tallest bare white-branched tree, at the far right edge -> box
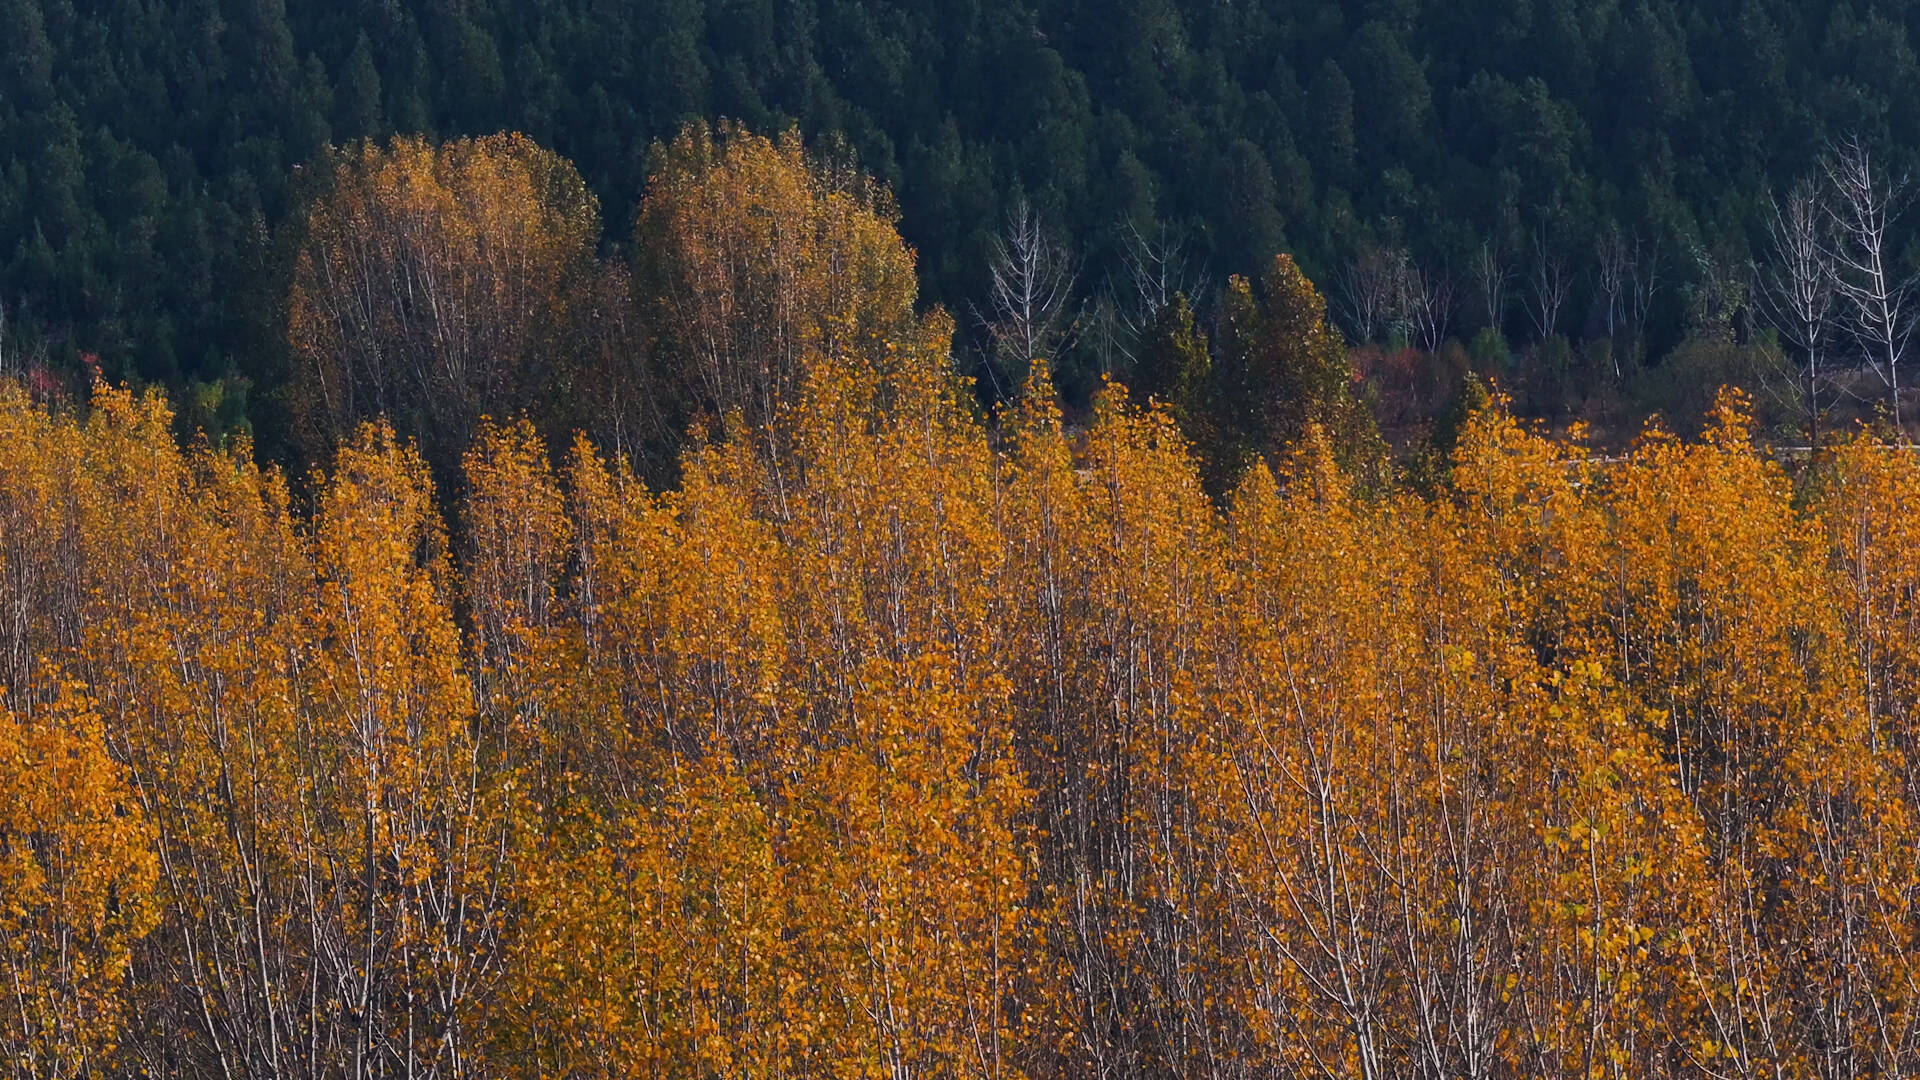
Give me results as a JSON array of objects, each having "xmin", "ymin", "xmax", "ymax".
[{"xmin": 1826, "ymin": 136, "xmax": 1914, "ymax": 436}]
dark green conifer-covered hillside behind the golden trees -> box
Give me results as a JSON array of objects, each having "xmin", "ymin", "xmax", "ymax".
[{"xmin": 11, "ymin": 0, "xmax": 1920, "ymax": 441}]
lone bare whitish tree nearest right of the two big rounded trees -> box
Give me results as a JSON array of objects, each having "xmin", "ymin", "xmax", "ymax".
[{"xmin": 973, "ymin": 200, "xmax": 1079, "ymax": 394}]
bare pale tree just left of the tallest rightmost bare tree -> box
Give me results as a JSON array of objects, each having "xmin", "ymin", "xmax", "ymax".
[{"xmin": 1755, "ymin": 179, "xmax": 1837, "ymax": 452}]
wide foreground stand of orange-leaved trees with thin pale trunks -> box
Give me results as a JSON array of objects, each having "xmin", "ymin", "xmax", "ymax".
[{"xmin": 11, "ymin": 127, "xmax": 1920, "ymax": 1080}]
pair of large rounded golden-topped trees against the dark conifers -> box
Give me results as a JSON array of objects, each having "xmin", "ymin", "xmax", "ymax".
[{"xmin": 288, "ymin": 125, "xmax": 918, "ymax": 475}]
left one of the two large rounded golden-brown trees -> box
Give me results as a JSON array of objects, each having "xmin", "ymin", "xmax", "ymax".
[{"xmin": 288, "ymin": 135, "xmax": 599, "ymax": 461}]
